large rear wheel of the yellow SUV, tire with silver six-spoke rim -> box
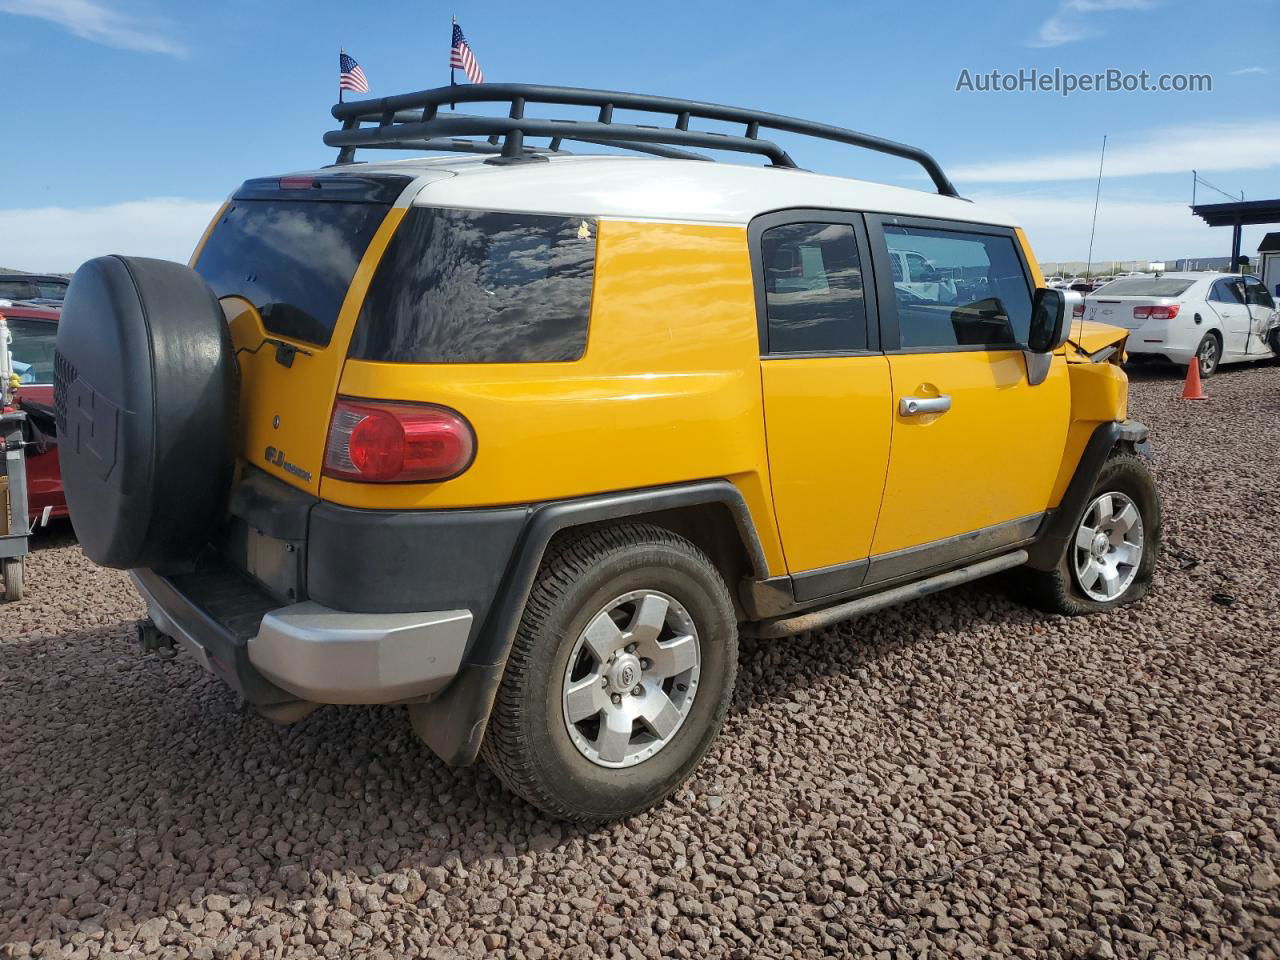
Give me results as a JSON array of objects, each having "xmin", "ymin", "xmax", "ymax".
[{"xmin": 481, "ymin": 524, "xmax": 737, "ymax": 823}]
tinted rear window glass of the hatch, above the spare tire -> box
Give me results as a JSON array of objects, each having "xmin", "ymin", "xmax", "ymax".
[{"xmin": 196, "ymin": 200, "xmax": 389, "ymax": 347}]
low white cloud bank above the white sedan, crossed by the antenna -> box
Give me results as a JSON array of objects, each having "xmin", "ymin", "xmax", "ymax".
[{"xmin": 972, "ymin": 189, "xmax": 1266, "ymax": 262}]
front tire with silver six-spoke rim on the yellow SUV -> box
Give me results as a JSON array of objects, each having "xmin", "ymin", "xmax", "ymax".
[{"xmin": 1019, "ymin": 453, "xmax": 1162, "ymax": 617}]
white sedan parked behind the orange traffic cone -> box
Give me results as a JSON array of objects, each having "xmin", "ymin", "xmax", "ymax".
[{"xmin": 1084, "ymin": 273, "xmax": 1280, "ymax": 376}]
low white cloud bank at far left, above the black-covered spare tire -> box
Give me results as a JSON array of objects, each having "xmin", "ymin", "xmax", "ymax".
[{"xmin": 0, "ymin": 197, "xmax": 219, "ymax": 273}]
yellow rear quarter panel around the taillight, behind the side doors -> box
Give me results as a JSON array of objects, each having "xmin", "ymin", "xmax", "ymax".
[{"xmin": 320, "ymin": 220, "xmax": 783, "ymax": 572}]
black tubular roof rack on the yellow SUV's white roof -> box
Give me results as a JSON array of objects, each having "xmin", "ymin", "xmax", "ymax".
[{"xmin": 324, "ymin": 83, "xmax": 957, "ymax": 197}]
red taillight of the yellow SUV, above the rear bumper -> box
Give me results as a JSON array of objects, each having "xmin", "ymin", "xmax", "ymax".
[{"xmin": 324, "ymin": 397, "xmax": 476, "ymax": 484}]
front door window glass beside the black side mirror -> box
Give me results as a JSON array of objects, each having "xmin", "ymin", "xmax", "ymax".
[{"xmin": 884, "ymin": 225, "xmax": 1032, "ymax": 349}]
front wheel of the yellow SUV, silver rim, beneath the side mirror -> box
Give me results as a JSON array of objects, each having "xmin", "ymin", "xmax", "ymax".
[{"xmin": 1021, "ymin": 453, "xmax": 1161, "ymax": 616}]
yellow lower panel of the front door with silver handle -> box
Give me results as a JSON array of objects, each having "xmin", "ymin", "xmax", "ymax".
[{"xmin": 872, "ymin": 351, "xmax": 1071, "ymax": 554}]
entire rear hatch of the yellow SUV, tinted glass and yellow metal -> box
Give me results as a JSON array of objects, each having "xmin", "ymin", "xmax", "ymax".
[{"xmin": 193, "ymin": 174, "xmax": 412, "ymax": 495}]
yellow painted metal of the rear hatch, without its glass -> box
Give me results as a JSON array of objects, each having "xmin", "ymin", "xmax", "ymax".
[{"xmin": 215, "ymin": 209, "xmax": 404, "ymax": 494}]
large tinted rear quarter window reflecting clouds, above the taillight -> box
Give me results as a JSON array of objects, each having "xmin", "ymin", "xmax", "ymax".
[{"xmin": 351, "ymin": 207, "xmax": 595, "ymax": 364}]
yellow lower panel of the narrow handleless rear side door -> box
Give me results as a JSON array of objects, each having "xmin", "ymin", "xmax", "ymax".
[{"xmin": 762, "ymin": 356, "xmax": 892, "ymax": 571}]
